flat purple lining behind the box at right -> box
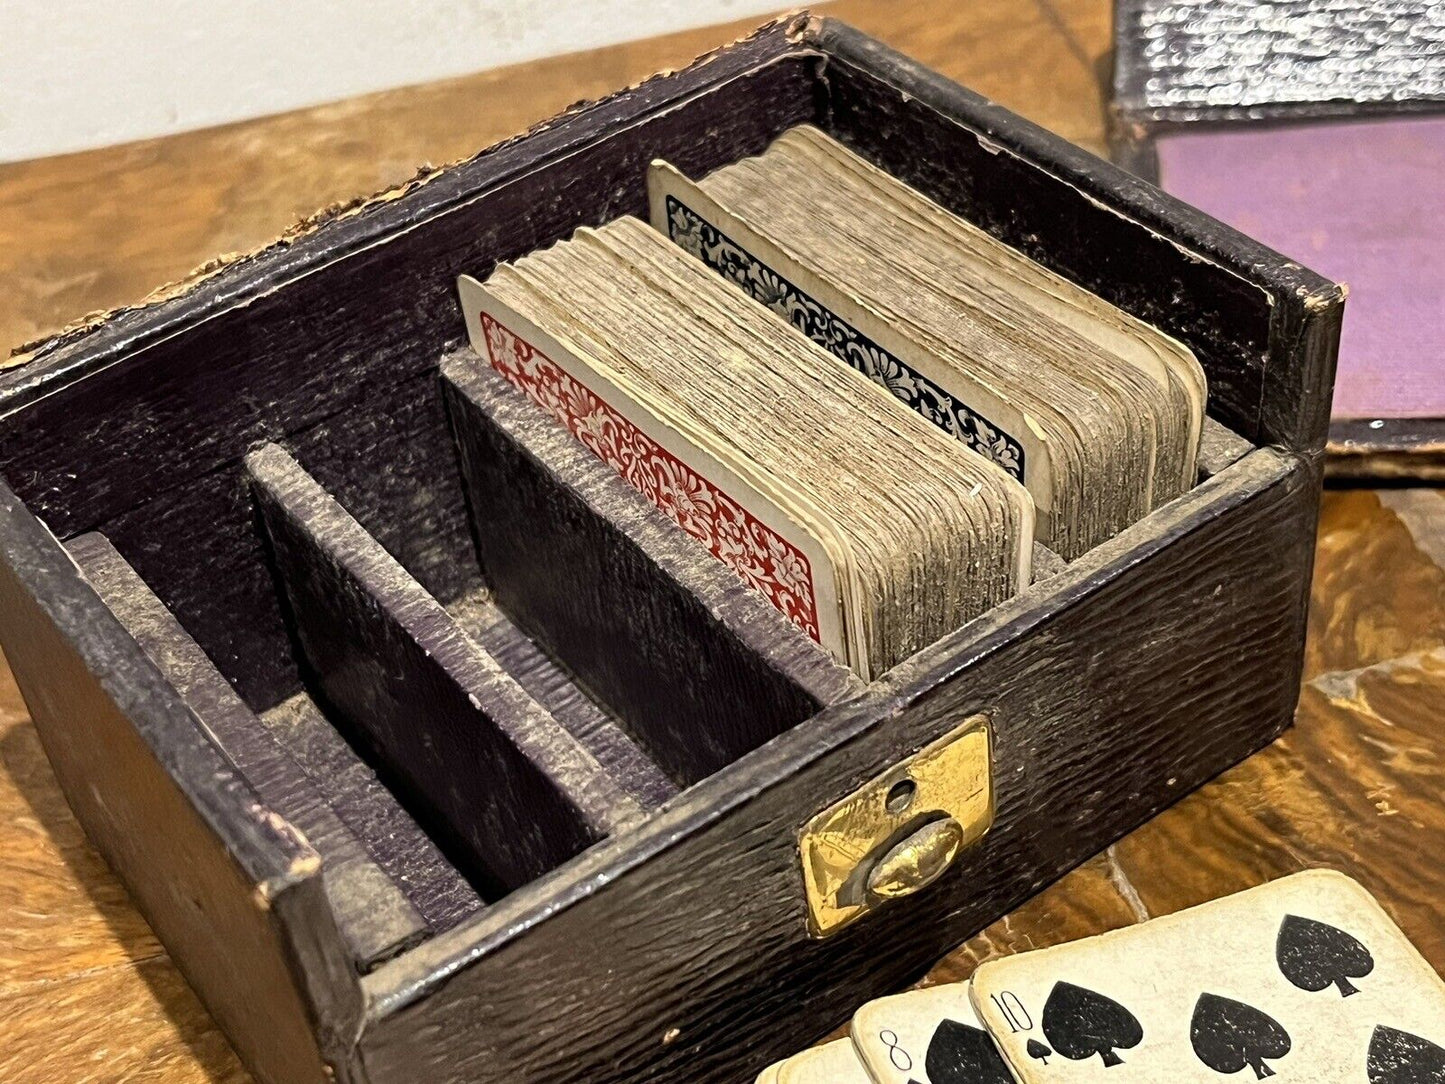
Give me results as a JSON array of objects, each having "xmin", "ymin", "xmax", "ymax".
[{"xmin": 1157, "ymin": 116, "xmax": 1445, "ymax": 418}]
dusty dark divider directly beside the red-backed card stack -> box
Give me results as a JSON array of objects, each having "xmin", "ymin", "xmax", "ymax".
[{"xmin": 441, "ymin": 358, "xmax": 863, "ymax": 785}]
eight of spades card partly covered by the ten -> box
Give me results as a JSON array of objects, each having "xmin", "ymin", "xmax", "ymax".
[{"xmin": 851, "ymin": 983, "xmax": 1013, "ymax": 1084}]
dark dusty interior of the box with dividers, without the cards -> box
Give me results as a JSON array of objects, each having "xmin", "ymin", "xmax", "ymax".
[{"xmin": 0, "ymin": 19, "xmax": 1312, "ymax": 1011}]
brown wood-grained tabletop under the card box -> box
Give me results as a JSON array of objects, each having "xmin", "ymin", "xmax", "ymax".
[{"xmin": 0, "ymin": 0, "xmax": 1445, "ymax": 1084}]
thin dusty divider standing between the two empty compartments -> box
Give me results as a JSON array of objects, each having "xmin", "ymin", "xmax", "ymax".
[{"xmin": 246, "ymin": 445, "xmax": 643, "ymax": 896}]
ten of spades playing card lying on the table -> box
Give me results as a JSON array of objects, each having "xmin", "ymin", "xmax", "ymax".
[{"xmin": 971, "ymin": 870, "xmax": 1445, "ymax": 1084}]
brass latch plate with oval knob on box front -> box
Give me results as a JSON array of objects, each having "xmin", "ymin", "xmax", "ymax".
[{"xmin": 798, "ymin": 714, "xmax": 993, "ymax": 938}]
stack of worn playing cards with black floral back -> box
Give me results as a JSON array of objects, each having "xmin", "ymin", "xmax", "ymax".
[{"xmin": 649, "ymin": 127, "xmax": 1205, "ymax": 558}]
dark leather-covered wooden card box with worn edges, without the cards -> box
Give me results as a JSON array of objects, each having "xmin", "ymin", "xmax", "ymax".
[{"xmin": 0, "ymin": 16, "xmax": 1342, "ymax": 1084}]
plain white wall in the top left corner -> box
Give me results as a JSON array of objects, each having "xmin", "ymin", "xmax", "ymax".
[{"xmin": 0, "ymin": 0, "xmax": 780, "ymax": 162}]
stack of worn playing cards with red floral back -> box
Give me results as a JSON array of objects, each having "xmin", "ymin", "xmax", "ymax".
[{"xmin": 461, "ymin": 218, "xmax": 1033, "ymax": 679}]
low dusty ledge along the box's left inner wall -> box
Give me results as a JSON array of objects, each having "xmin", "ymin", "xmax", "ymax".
[{"xmin": 66, "ymin": 533, "xmax": 450, "ymax": 971}]
